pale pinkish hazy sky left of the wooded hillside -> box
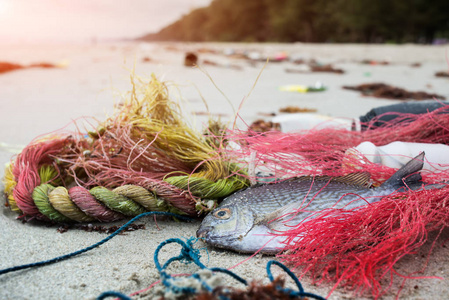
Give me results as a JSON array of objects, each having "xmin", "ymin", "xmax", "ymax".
[{"xmin": 0, "ymin": 0, "xmax": 211, "ymax": 43}]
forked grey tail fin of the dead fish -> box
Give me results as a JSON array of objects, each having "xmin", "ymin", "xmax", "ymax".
[{"xmin": 381, "ymin": 152, "xmax": 425, "ymax": 188}]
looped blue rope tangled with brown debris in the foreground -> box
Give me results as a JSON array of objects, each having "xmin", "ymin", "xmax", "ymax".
[{"xmin": 149, "ymin": 238, "xmax": 324, "ymax": 300}]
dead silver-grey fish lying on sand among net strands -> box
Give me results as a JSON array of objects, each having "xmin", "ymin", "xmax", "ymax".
[{"xmin": 196, "ymin": 152, "xmax": 434, "ymax": 254}]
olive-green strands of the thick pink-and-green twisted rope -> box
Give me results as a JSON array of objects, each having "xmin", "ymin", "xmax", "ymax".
[{"xmin": 32, "ymin": 172, "xmax": 247, "ymax": 222}]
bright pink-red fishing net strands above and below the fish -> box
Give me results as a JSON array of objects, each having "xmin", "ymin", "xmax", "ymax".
[{"xmin": 227, "ymin": 106, "xmax": 449, "ymax": 298}]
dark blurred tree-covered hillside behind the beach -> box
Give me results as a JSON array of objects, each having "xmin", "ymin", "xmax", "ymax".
[{"xmin": 142, "ymin": 0, "xmax": 449, "ymax": 43}]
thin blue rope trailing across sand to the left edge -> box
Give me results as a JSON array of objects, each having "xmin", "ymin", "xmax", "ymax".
[{"xmin": 0, "ymin": 211, "xmax": 192, "ymax": 275}]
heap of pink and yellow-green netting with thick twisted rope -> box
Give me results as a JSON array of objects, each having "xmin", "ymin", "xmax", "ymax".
[{"xmin": 4, "ymin": 76, "xmax": 248, "ymax": 222}]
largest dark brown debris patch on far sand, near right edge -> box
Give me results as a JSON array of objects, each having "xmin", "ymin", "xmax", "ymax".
[{"xmin": 343, "ymin": 83, "xmax": 446, "ymax": 100}]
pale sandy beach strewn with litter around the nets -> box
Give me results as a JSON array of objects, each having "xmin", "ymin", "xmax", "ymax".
[{"xmin": 0, "ymin": 42, "xmax": 449, "ymax": 299}]
